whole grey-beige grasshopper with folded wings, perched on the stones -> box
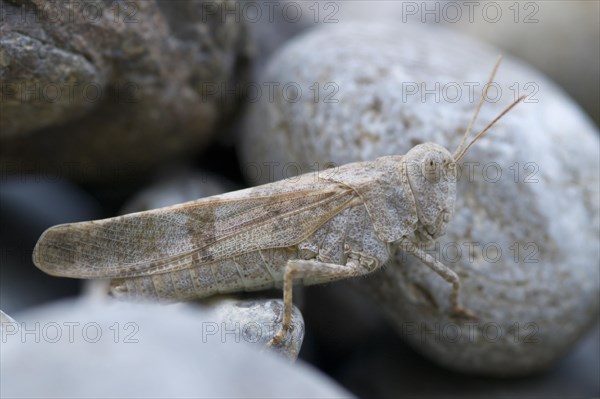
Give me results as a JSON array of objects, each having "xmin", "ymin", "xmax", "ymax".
[{"xmin": 33, "ymin": 59, "xmax": 523, "ymax": 344}]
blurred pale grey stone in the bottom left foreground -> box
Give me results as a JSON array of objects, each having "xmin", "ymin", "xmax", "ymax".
[{"xmin": 0, "ymin": 301, "xmax": 344, "ymax": 398}]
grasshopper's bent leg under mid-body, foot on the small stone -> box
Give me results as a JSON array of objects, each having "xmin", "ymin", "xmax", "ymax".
[{"xmin": 267, "ymin": 259, "xmax": 366, "ymax": 346}]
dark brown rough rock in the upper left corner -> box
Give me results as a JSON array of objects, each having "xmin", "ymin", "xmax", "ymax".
[{"xmin": 0, "ymin": 0, "xmax": 252, "ymax": 181}]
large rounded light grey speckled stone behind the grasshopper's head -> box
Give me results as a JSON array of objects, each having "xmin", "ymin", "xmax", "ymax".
[{"xmin": 240, "ymin": 23, "xmax": 600, "ymax": 376}]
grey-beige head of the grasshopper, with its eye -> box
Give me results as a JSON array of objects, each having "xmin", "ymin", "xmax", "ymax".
[{"xmin": 405, "ymin": 143, "xmax": 456, "ymax": 242}]
